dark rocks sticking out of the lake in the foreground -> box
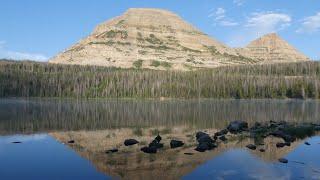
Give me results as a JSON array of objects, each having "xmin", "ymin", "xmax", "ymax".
[{"xmin": 106, "ymin": 121, "xmax": 320, "ymax": 158}]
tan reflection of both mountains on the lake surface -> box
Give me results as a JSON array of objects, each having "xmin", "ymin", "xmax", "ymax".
[{"xmin": 50, "ymin": 126, "xmax": 312, "ymax": 179}]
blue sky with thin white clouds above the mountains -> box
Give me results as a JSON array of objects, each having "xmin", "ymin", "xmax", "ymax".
[{"xmin": 0, "ymin": 0, "xmax": 320, "ymax": 61}]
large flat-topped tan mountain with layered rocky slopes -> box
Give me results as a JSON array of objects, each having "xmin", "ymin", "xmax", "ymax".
[{"xmin": 50, "ymin": 9, "xmax": 255, "ymax": 70}]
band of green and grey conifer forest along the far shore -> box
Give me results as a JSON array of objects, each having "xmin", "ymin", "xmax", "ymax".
[{"xmin": 0, "ymin": 61, "xmax": 320, "ymax": 98}]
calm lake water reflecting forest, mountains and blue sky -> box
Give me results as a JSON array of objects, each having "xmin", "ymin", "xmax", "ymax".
[{"xmin": 0, "ymin": 99, "xmax": 320, "ymax": 180}]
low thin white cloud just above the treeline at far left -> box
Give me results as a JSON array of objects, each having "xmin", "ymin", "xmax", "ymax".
[{"xmin": 0, "ymin": 41, "xmax": 48, "ymax": 62}]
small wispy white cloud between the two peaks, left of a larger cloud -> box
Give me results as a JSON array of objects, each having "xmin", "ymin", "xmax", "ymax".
[{"xmin": 208, "ymin": 7, "xmax": 239, "ymax": 26}]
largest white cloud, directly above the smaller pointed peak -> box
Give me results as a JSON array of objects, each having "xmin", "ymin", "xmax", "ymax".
[{"xmin": 227, "ymin": 12, "xmax": 292, "ymax": 47}]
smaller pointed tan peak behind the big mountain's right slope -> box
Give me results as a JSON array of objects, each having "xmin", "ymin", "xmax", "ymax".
[{"xmin": 238, "ymin": 33, "xmax": 310, "ymax": 63}]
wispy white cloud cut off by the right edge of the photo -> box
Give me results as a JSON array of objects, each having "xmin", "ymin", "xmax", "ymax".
[{"xmin": 297, "ymin": 12, "xmax": 320, "ymax": 33}]
